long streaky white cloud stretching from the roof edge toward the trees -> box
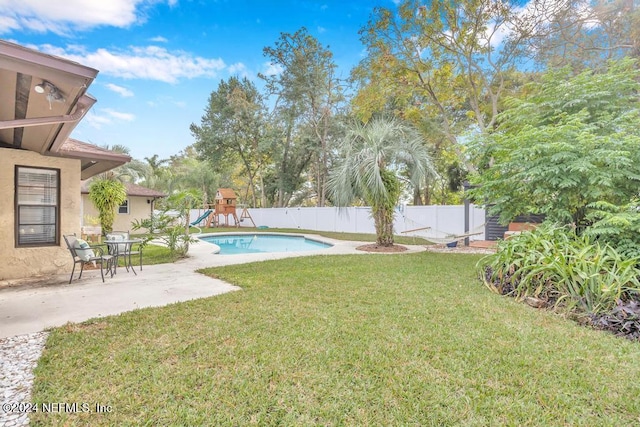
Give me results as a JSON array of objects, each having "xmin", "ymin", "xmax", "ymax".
[{"xmin": 37, "ymin": 44, "xmax": 226, "ymax": 83}]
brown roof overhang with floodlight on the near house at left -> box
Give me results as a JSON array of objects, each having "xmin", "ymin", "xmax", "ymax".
[{"xmin": 0, "ymin": 40, "xmax": 131, "ymax": 179}]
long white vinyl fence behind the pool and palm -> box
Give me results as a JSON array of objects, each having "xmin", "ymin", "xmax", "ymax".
[{"xmin": 191, "ymin": 205, "xmax": 485, "ymax": 240}]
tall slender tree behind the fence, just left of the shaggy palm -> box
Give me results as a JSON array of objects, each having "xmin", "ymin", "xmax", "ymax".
[{"xmin": 259, "ymin": 27, "xmax": 344, "ymax": 206}]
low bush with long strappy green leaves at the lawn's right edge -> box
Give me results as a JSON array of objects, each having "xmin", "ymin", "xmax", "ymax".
[{"xmin": 479, "ymin": 224, "xmax": 640, "ymax": 314}]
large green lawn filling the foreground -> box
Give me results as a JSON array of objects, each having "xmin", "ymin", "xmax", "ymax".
[{"xmin": 31, "ymin": 253, "xmax": 640, "ymax": 426}]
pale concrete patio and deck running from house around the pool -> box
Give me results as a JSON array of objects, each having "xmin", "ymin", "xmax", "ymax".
[{"xmin": 0, "ymin": 233, "xmax": 425, "ymax": 338}]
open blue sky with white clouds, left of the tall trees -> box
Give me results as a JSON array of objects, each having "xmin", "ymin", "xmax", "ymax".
[{"xmin": 0, "ymin": 0, "xmax": 394, "ymax": 160}]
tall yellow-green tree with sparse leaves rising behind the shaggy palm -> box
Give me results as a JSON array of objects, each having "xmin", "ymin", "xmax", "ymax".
[{"xmin": 354, "ymin": 0, "xmax": 526, "ymax": 172}]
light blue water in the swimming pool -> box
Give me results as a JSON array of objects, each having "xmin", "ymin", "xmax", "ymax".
[{"xmin": 200, "ymin": 234, "xmax": 332, "ymax": 255}]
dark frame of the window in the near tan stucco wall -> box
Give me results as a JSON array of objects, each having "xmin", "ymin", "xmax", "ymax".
[{"xmin": 13, "ymin": 165, "xmax": 62, "ymax": 248}]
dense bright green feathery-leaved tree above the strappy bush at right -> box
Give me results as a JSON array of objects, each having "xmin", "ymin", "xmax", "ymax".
[{"xmin": 475, "ymin": 59, "xmax": 640, "ymax": 227}]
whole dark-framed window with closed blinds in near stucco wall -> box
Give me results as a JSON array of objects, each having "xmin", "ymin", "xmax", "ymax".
[{"xmin": 15, "ymin": 166, "xmax": 60, "ymax": 246}]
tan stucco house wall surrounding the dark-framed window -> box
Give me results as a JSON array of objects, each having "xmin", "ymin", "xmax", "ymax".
[{"xmin": 0, "ymin": 148, "xmax": 80, "ymax": 280}]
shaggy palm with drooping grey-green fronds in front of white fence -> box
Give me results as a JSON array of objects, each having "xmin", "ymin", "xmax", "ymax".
[{"xmin": 329, "ymin": 118, "xmax": 436, "ymax": 246}]
